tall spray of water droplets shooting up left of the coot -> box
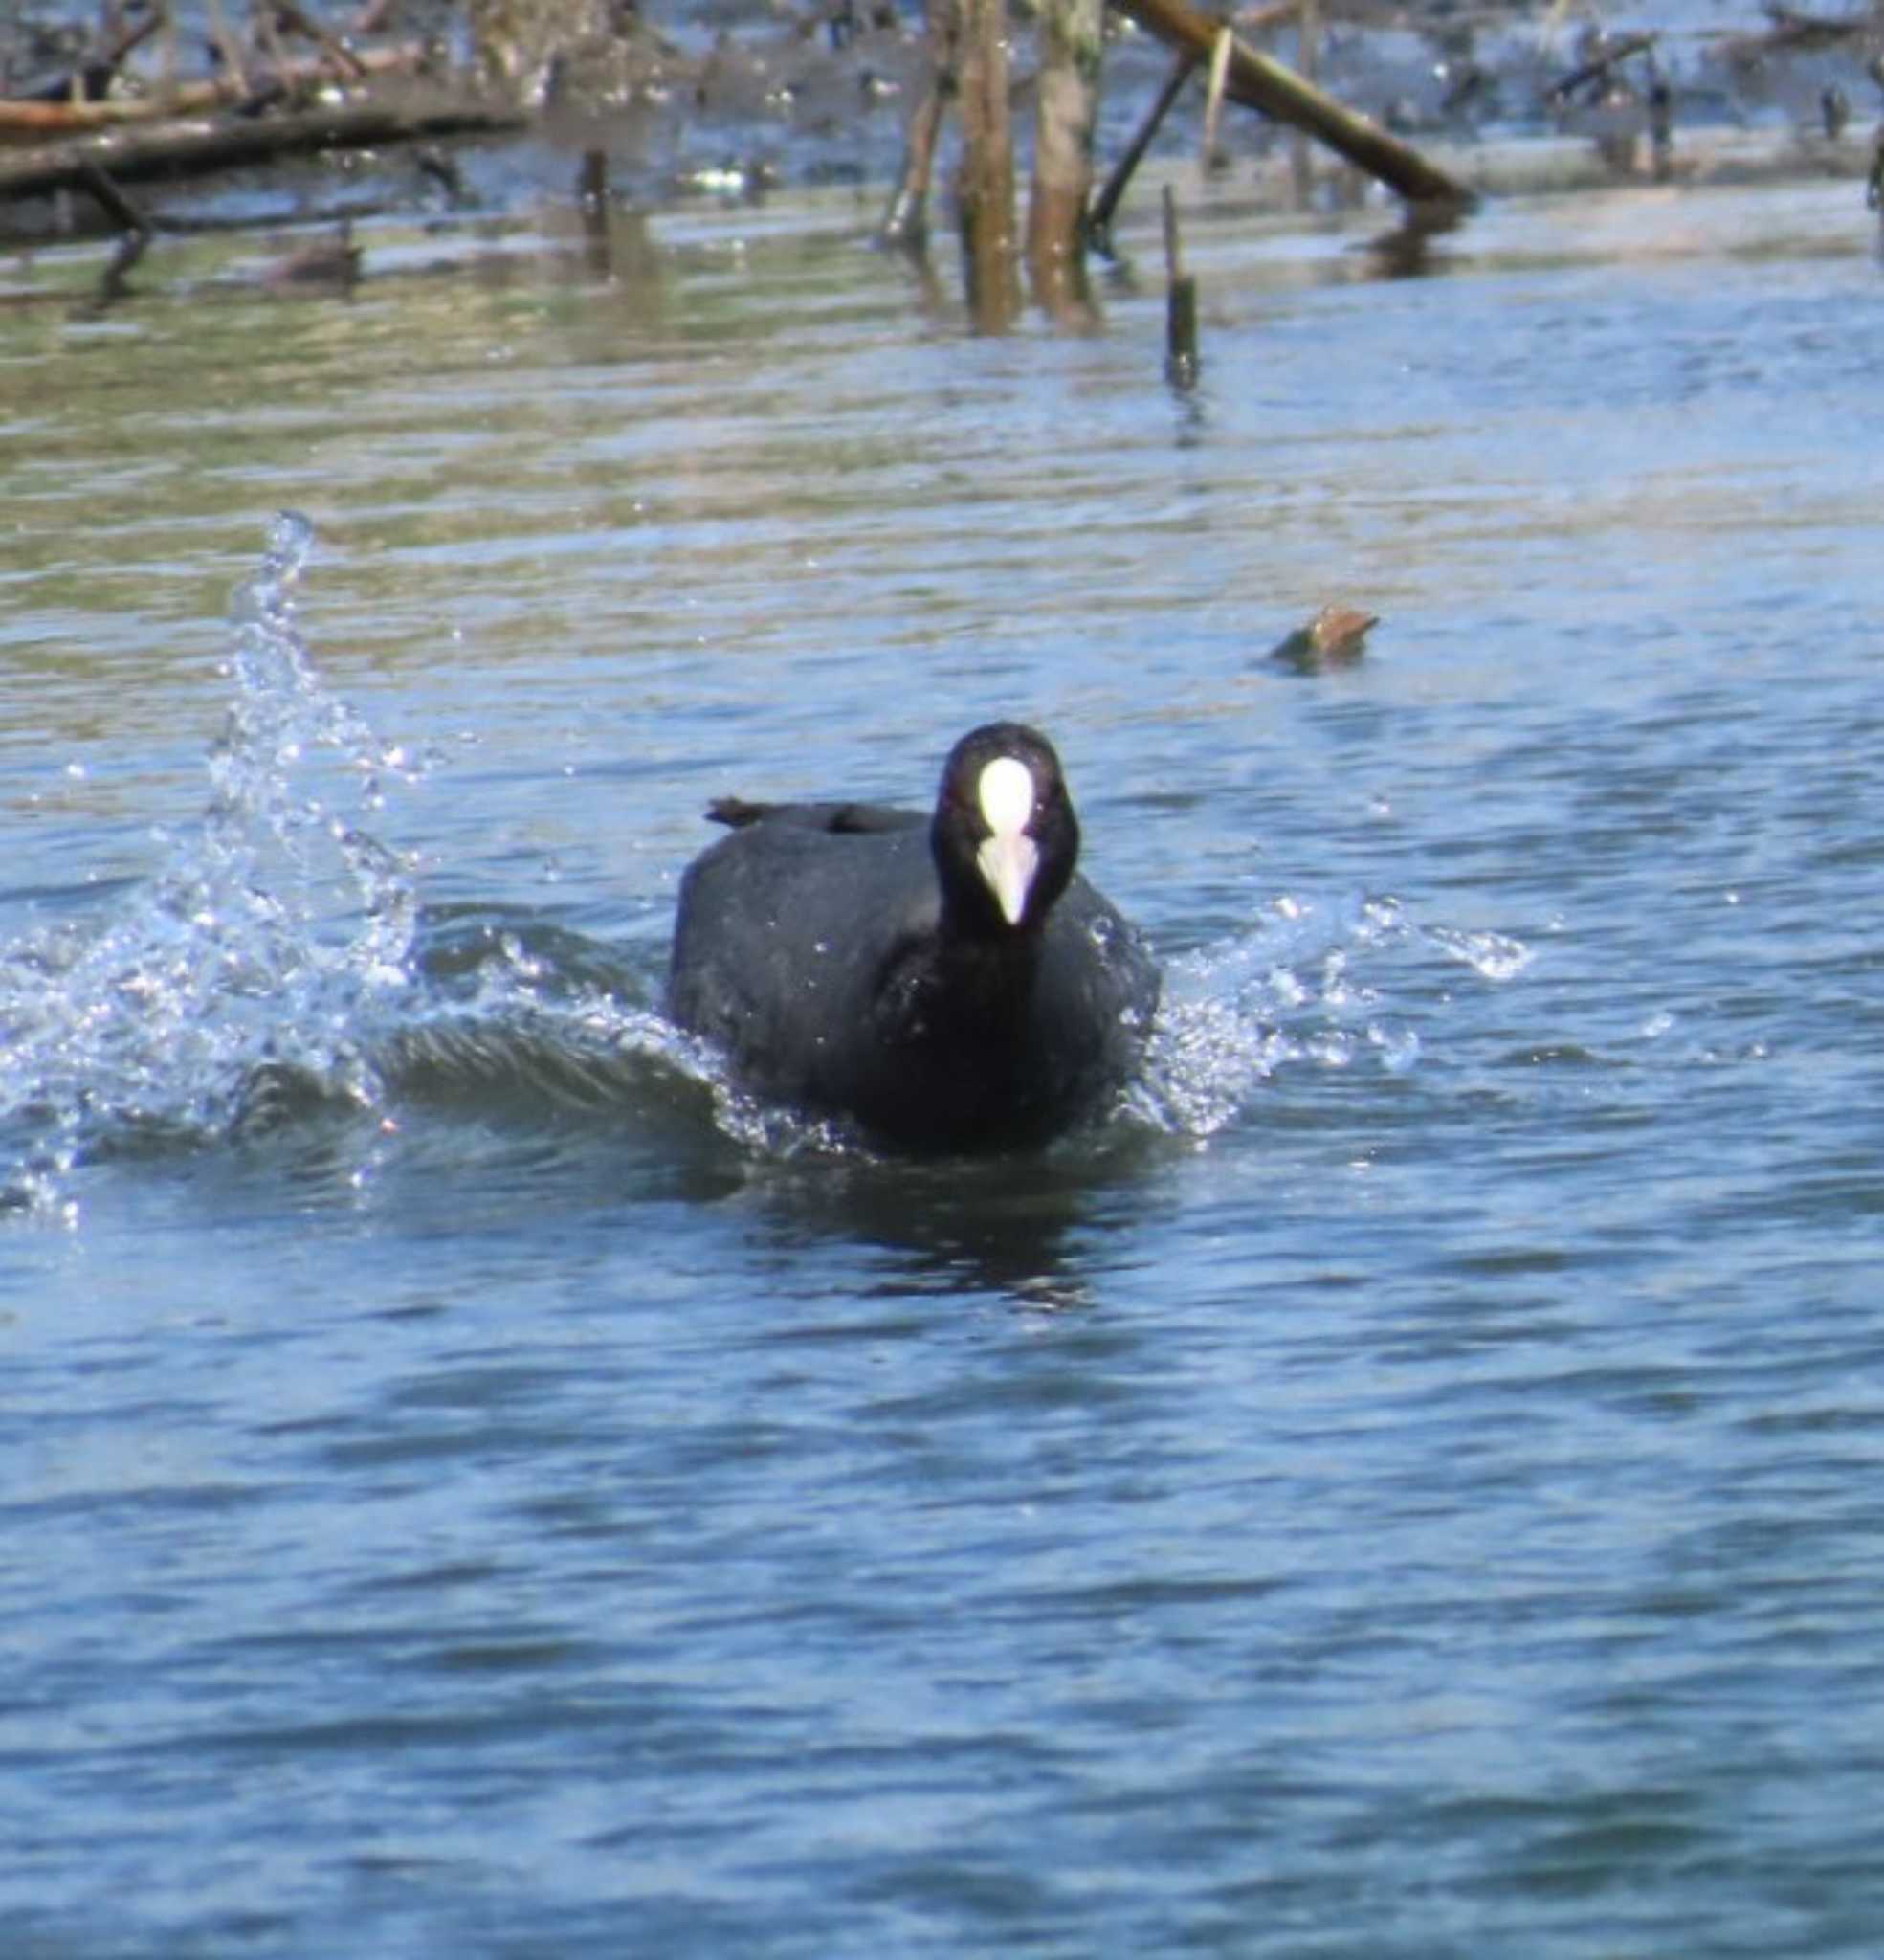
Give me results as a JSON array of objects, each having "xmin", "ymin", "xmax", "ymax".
[{"xmin": 0, "ymin": 514, "xmax": 433, "ymax": 1217}]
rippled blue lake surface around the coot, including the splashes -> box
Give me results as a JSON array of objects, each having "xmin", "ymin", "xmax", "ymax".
[{"xmin": 0, "ymin": 160, "xmax": 1884, "ymax": 1960}]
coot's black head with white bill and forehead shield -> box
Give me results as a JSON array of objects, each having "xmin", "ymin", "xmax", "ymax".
[{"xmin": 929, "ymin": 722, "xmax": 1080, "ymax": 935}]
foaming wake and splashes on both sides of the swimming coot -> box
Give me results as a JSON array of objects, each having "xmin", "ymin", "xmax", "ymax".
[{"xmin": 0, "ymin": 514, "xmax": 1531, "ymax": 1219}]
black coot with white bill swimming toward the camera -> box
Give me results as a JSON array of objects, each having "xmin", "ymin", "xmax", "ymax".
[{"xmin": 667, "ymin": 722, "xmax": 1159, "ymax": 1150}]
